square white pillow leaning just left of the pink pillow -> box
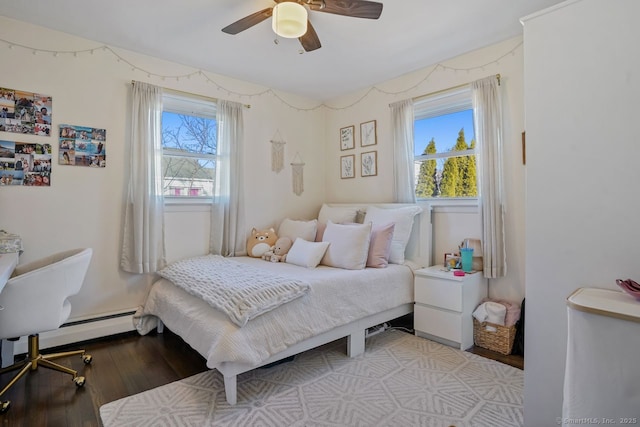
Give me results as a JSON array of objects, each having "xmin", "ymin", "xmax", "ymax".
[{"xmin": 321, "ymin": 221, "xmax": 371, "ymax": 270}]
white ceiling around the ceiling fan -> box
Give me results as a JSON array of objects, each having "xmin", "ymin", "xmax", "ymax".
[{"xmin": 0, "ymin": 0, "xmax": 561, "ymax": 100}]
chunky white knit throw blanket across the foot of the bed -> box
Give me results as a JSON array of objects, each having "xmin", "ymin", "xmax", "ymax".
[{"xmin": 158, "ymin": 255, "xmax": 310, "ymax": 327}]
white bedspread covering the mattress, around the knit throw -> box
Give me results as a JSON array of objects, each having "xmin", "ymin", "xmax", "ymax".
[{"xmin": 135, "ymin": 257, "xmax": 413, "ymax": 369}]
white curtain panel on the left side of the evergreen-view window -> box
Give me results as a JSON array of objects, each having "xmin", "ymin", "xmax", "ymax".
[{"xmin": 389, "ymin": 99, "xmax": 416, "ymax": 203}]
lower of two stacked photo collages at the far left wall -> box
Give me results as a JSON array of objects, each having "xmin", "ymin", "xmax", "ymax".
[{"xmin": 0, "ymin": 141, "xmax": 51, "ymax": 186}]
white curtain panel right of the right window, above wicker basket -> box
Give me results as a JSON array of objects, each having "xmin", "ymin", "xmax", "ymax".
[{"xmin": 471, "ymin": 76, "xmax": 507, "ymax": 278}]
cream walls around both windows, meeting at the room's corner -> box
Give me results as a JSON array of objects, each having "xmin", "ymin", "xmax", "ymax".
[{"xmin": 0, "ymin": 17, "xmax": 524, "ymax": 338}]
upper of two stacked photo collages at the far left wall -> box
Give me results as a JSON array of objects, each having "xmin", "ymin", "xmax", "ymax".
[{"xmin": 0, "ymin": 87, "xmax": 53, "ymax": 136}]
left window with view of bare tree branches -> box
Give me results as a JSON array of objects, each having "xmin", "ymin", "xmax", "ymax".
[{"xmin": 162, "ymin": 92, "xmax": 218, "ymax": 200}]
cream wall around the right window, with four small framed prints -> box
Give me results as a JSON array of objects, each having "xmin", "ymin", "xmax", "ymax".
[{"xmin": 326, "ymin": 37, "xmax": 524, "ymax": 303}]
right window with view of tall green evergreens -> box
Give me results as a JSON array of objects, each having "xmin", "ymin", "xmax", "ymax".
[{"xmin": 414, "ymin": 86, "xmax": 478, "ymax": 199}]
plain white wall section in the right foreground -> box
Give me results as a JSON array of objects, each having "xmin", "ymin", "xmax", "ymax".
[{"xmin": 524, "ymin": 0, "xmax": 640, "ymax": 427}]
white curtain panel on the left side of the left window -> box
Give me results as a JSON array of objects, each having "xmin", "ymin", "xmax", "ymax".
[{"xmin": 120, "ymin": 82, "xmax": 166, "ymax": 274}]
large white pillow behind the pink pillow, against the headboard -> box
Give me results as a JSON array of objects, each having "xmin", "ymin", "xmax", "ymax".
[{"xmin": 364, "ymin": 206, "xmax": 422, "ymax": 264}]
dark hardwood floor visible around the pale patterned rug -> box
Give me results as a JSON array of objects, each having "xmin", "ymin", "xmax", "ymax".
[{"xmin": 0, "ymin": 328, "xmax": 524, "ymax": 427}]
